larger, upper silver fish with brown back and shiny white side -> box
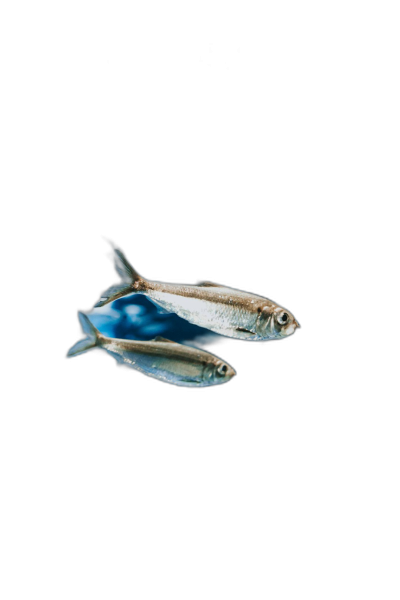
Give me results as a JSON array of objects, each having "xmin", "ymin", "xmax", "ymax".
[{"xmin": 95, "ymin": 247, "xmax": 300, "ymax": 340}]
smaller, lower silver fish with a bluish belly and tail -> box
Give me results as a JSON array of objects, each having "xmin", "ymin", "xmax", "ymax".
[{"xmin": 67, "ymin": 312, "xmax": 236, "ymax": 387}]
